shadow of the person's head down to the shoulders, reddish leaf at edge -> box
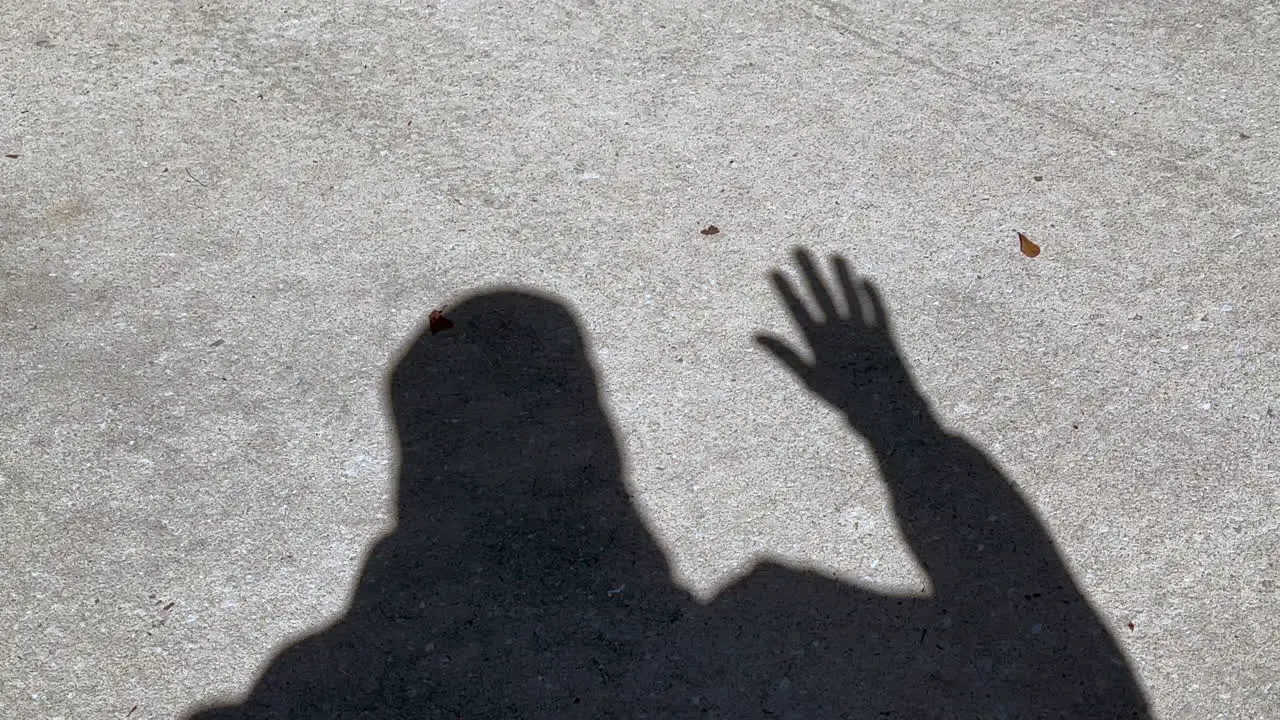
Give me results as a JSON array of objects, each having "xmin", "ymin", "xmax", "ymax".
[{"xmin": 388, "ymin": 290, "xmax": 666, "ymax": 584}]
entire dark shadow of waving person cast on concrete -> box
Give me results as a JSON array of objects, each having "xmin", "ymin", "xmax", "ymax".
[{"xmin": 196, "ymin": 265, "xmax": 1148, "ymax": 720}]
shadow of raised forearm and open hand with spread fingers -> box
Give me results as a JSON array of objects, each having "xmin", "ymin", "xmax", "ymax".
[{"xmin": 758, "ymin": 250, "xmax": 1071, "ymax": 603}]
